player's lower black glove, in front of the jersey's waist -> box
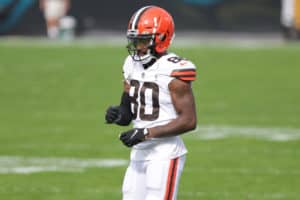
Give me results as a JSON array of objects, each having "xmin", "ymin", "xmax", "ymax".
[{"xmin": 120, "ymin": 128, "xmax": 148, "ymax": 147}]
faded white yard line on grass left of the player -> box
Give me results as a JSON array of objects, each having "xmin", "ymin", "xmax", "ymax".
[{"xmin": 0, "ymin": 156, "xmax": 127, "ymax": 174}]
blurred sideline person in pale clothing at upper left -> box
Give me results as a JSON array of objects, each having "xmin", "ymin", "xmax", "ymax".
[{"xmin": 40, "ymin": 0, "xmax": 70, "ymax": 39}]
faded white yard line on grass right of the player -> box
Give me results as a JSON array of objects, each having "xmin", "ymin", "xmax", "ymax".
[{"xmin": 187, "ymin": 125, "xmax": 300, "ymax": 142}]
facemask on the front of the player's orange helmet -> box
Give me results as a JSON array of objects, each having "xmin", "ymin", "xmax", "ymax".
[{"xmin": 126, "ymin": 33, "xmax": 156, "ymax": 64}]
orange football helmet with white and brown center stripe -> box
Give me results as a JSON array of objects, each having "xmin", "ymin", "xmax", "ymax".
[{"xmin": 127, "ymin": 6, "xmax": 174, "ymax": 63}]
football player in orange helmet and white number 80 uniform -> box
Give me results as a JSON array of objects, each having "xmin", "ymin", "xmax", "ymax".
[{"xmin": 105, "ymin": 6, "xmax": 197, "ymax": 200}]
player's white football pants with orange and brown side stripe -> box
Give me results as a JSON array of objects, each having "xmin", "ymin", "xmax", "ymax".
[{"xmin": 122, "ymin": 155, "xmax": 185, "ymax": 200}]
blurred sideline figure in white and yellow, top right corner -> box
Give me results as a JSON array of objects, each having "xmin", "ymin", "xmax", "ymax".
[{"xmin": 280, "ymin": 0, "xmax": 300, "ymax": 39}]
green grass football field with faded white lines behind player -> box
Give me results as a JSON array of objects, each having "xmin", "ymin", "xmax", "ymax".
[{"xmin": 0, "ymin": 38, "xmax": 300, "ymax": 200}]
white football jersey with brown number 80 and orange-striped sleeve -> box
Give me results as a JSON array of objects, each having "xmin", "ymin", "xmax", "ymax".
[{"xmin": 123, "ymin": 53, "xmax": 196, "ymax": 160}]
